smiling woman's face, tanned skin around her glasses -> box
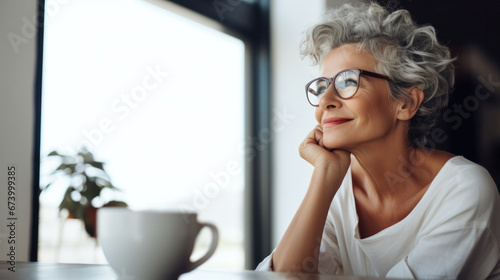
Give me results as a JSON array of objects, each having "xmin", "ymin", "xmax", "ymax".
[{"xmin": 315, "ymin": 44, "xmax": 399, "ymax": 152}]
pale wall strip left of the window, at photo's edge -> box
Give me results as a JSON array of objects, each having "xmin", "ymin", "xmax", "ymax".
[{"xmin": 0, "ymin": 0, "xmax": 37, "ymax": 261}]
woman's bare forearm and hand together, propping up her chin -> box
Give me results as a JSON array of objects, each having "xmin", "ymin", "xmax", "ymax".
[{"xmin": 272, "ymin": 125, "xmax": 351, "ymax": 273}]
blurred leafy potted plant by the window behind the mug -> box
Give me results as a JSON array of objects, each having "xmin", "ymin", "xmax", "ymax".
[{"xmin": 41, "ymin": 148, "xmax": 127, "ymax": 237}]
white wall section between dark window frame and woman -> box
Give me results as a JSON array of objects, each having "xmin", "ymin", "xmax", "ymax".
[{"xmin": 270, "ymin": 0, "xmax": 326, "ymax": 246}]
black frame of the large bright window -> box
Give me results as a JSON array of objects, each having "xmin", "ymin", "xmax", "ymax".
[{"xmin": 30, "ymin": 0, "xmax": 272, "ymax": 269}]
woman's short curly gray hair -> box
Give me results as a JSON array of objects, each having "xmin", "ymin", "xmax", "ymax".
[{"xmin": 300, "ymin": 3, "xmax": 455, "ymax": 146}]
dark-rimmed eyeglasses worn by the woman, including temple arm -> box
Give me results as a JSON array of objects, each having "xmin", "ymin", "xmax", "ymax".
[{"xmin": 306, "ymin": 69, "xmax": 389, "ymax": 107}]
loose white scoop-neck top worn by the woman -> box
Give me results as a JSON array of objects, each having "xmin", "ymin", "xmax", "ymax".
[{"xmin": 257, "ymin": 156, "xmax": 500, "ymax": 280}]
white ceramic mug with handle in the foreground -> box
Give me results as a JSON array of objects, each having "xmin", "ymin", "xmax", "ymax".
[{"xmin": 97, "ymin": 207, "xmax": 219, "ymax": 280}]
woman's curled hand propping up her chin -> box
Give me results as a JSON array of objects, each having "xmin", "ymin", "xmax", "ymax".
[{"xmin": 299, "ymin": 125, "xmax": 351, "ymax": 172}]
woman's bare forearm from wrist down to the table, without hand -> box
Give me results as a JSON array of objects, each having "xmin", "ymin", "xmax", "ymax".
[{"xmin": 273, "ymin": 166, "xmax": 345, "ymax": 272}]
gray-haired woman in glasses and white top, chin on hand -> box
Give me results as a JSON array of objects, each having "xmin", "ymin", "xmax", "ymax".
[{"xmin": 257, "ymin": 4, "xmax": 500, "ymax": 279}]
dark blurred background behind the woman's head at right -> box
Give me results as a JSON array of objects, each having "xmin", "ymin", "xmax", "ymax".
[{"xmin": 379, "ymin": 0, "xmax": 500, "ymax": 197}]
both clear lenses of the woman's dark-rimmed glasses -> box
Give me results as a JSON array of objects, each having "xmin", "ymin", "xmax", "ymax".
[{"xmin": 307, "ymin": 70, "xmax": 359, "ymax": 106}]
